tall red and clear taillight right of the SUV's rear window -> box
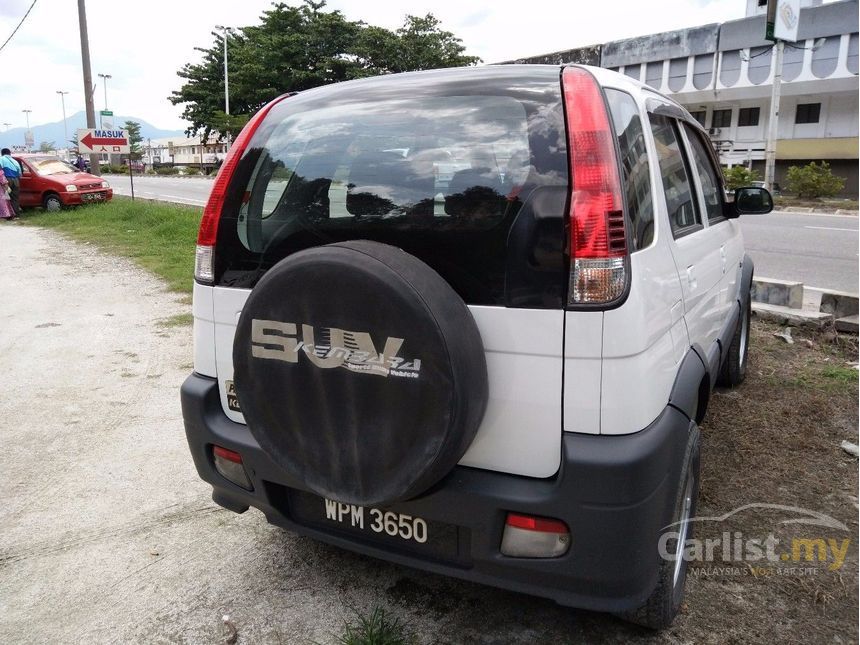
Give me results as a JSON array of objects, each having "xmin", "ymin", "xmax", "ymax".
[{"xmin": 562, "ymin": 67, "xmax": 628, "ymax": 305}]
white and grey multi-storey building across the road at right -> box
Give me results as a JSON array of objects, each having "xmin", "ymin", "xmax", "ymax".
[{"xmin": 510, "ymin": 0, "xmax": 858, "ymax": 197}]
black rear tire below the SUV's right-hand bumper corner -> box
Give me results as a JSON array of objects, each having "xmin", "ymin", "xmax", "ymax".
[{"xmin": 619, "ymin": 425, "xmax": 700, "ymax": 630}]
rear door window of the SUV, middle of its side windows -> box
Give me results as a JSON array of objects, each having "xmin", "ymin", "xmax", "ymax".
[{"xmin": 648, "ymin": 114, "xmax": 702, "ymax": 238}]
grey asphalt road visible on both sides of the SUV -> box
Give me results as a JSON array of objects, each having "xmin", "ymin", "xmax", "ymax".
[{"xmin": 109, "ymin": 175, "xmax": 858, "ymax": 293}]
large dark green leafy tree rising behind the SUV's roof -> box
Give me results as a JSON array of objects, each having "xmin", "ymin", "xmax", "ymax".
[{"xmin": 169, "ymin": 0, "xmax": 480, "ymax": 140}]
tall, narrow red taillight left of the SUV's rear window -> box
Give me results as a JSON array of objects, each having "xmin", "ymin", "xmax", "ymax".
[{"xmin": 194, "ymin": 94, "xmax": 290, "ymax": 284}]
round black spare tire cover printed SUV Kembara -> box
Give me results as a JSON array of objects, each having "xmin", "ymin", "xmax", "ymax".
[{"xmin": 233, "ymin": 241, "xmax": 488, "ymax": 505}]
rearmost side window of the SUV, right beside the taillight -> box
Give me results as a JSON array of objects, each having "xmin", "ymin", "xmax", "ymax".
[{"xmin": 606, "ymin": 89, "xmax": 654, "ymax": 251}]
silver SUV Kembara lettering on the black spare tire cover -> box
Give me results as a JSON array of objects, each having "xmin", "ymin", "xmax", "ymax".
[{"xmin": 251, "ymin": 318, "xmax": 421, "ymax": 378}]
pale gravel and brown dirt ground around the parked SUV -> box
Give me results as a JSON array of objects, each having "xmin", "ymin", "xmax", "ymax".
[{"xmin": 0, "ymin": 224, "xmax": 858, "ymax": 643}]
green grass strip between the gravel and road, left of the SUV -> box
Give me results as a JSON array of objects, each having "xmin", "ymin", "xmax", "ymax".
[{"xmin": 22, "ymin": 198, "xmax": 203, "ymax": 294}]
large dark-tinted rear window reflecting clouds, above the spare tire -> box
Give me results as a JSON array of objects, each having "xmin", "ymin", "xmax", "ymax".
[{"xmin": 216, "ymin": 67, "xmax": 568, "ymax": 306}]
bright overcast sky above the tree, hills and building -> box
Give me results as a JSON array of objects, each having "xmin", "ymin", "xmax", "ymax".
[{"xmin": 0, "ymin": 0, "xmax": 746, "ymax": 130}]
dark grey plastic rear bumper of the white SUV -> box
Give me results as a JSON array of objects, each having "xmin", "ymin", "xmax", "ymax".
[{"xmin": 182, "ymin": 374, "xmax": 692, "ymax": 611}]
